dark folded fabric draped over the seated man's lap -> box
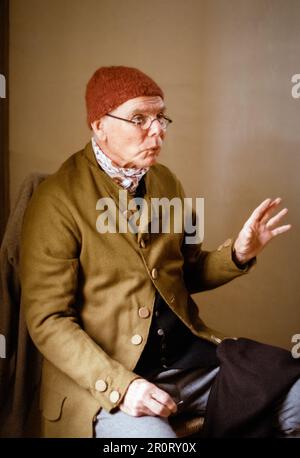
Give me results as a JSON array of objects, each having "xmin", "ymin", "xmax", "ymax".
[{"xmin": 203, "ymin": 338, "xmax": 300, "ymax": 438}]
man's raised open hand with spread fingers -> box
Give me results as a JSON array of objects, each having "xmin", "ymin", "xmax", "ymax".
[{"xmin": 234, "ymin": 197, "xmax": 291, "ymax": 264}]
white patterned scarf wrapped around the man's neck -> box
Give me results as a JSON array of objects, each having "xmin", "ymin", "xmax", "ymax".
[{"xmin": 92, "ymin": 138, "xmax": 149, "ymax": 192}]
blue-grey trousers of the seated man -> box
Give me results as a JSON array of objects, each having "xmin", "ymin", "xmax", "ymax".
[{"xmin": 94, "ymin": 367, "xmax": 300, "ymax": 438}]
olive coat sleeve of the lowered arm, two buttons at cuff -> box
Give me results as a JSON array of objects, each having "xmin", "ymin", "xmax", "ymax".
[{"xmin": 20, "ymin": 183, "xmax": 138, "ymax": 411}]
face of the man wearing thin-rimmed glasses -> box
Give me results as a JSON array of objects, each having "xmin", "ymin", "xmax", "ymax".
[{"xmin": 92, "ymin": 96, "xmax": 166, "ymax": 168}]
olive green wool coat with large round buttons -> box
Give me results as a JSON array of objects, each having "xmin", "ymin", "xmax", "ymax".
[{"xmin": 20, "ymin": 143, "xmax": 252, "ymax": 437}]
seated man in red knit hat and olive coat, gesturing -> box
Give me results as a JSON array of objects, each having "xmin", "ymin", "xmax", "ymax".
[{"xmin": 21, "ymin": 67, "xmax": 300, "ymax": 437}]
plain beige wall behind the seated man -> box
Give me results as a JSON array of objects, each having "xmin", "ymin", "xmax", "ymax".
[{"xmin": 10, "ymin": 0, "xmax": 300, "ymax": 348}]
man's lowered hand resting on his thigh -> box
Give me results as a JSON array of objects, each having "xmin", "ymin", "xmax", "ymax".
[{"xmin": 120, "ymin": 378, "xmax": 177, "ymax": 417}]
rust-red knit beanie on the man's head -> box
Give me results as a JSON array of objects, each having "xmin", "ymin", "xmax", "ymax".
[{"xmin": 85, "ymin": 66, "xmax": 164, "ymax": 126}]
